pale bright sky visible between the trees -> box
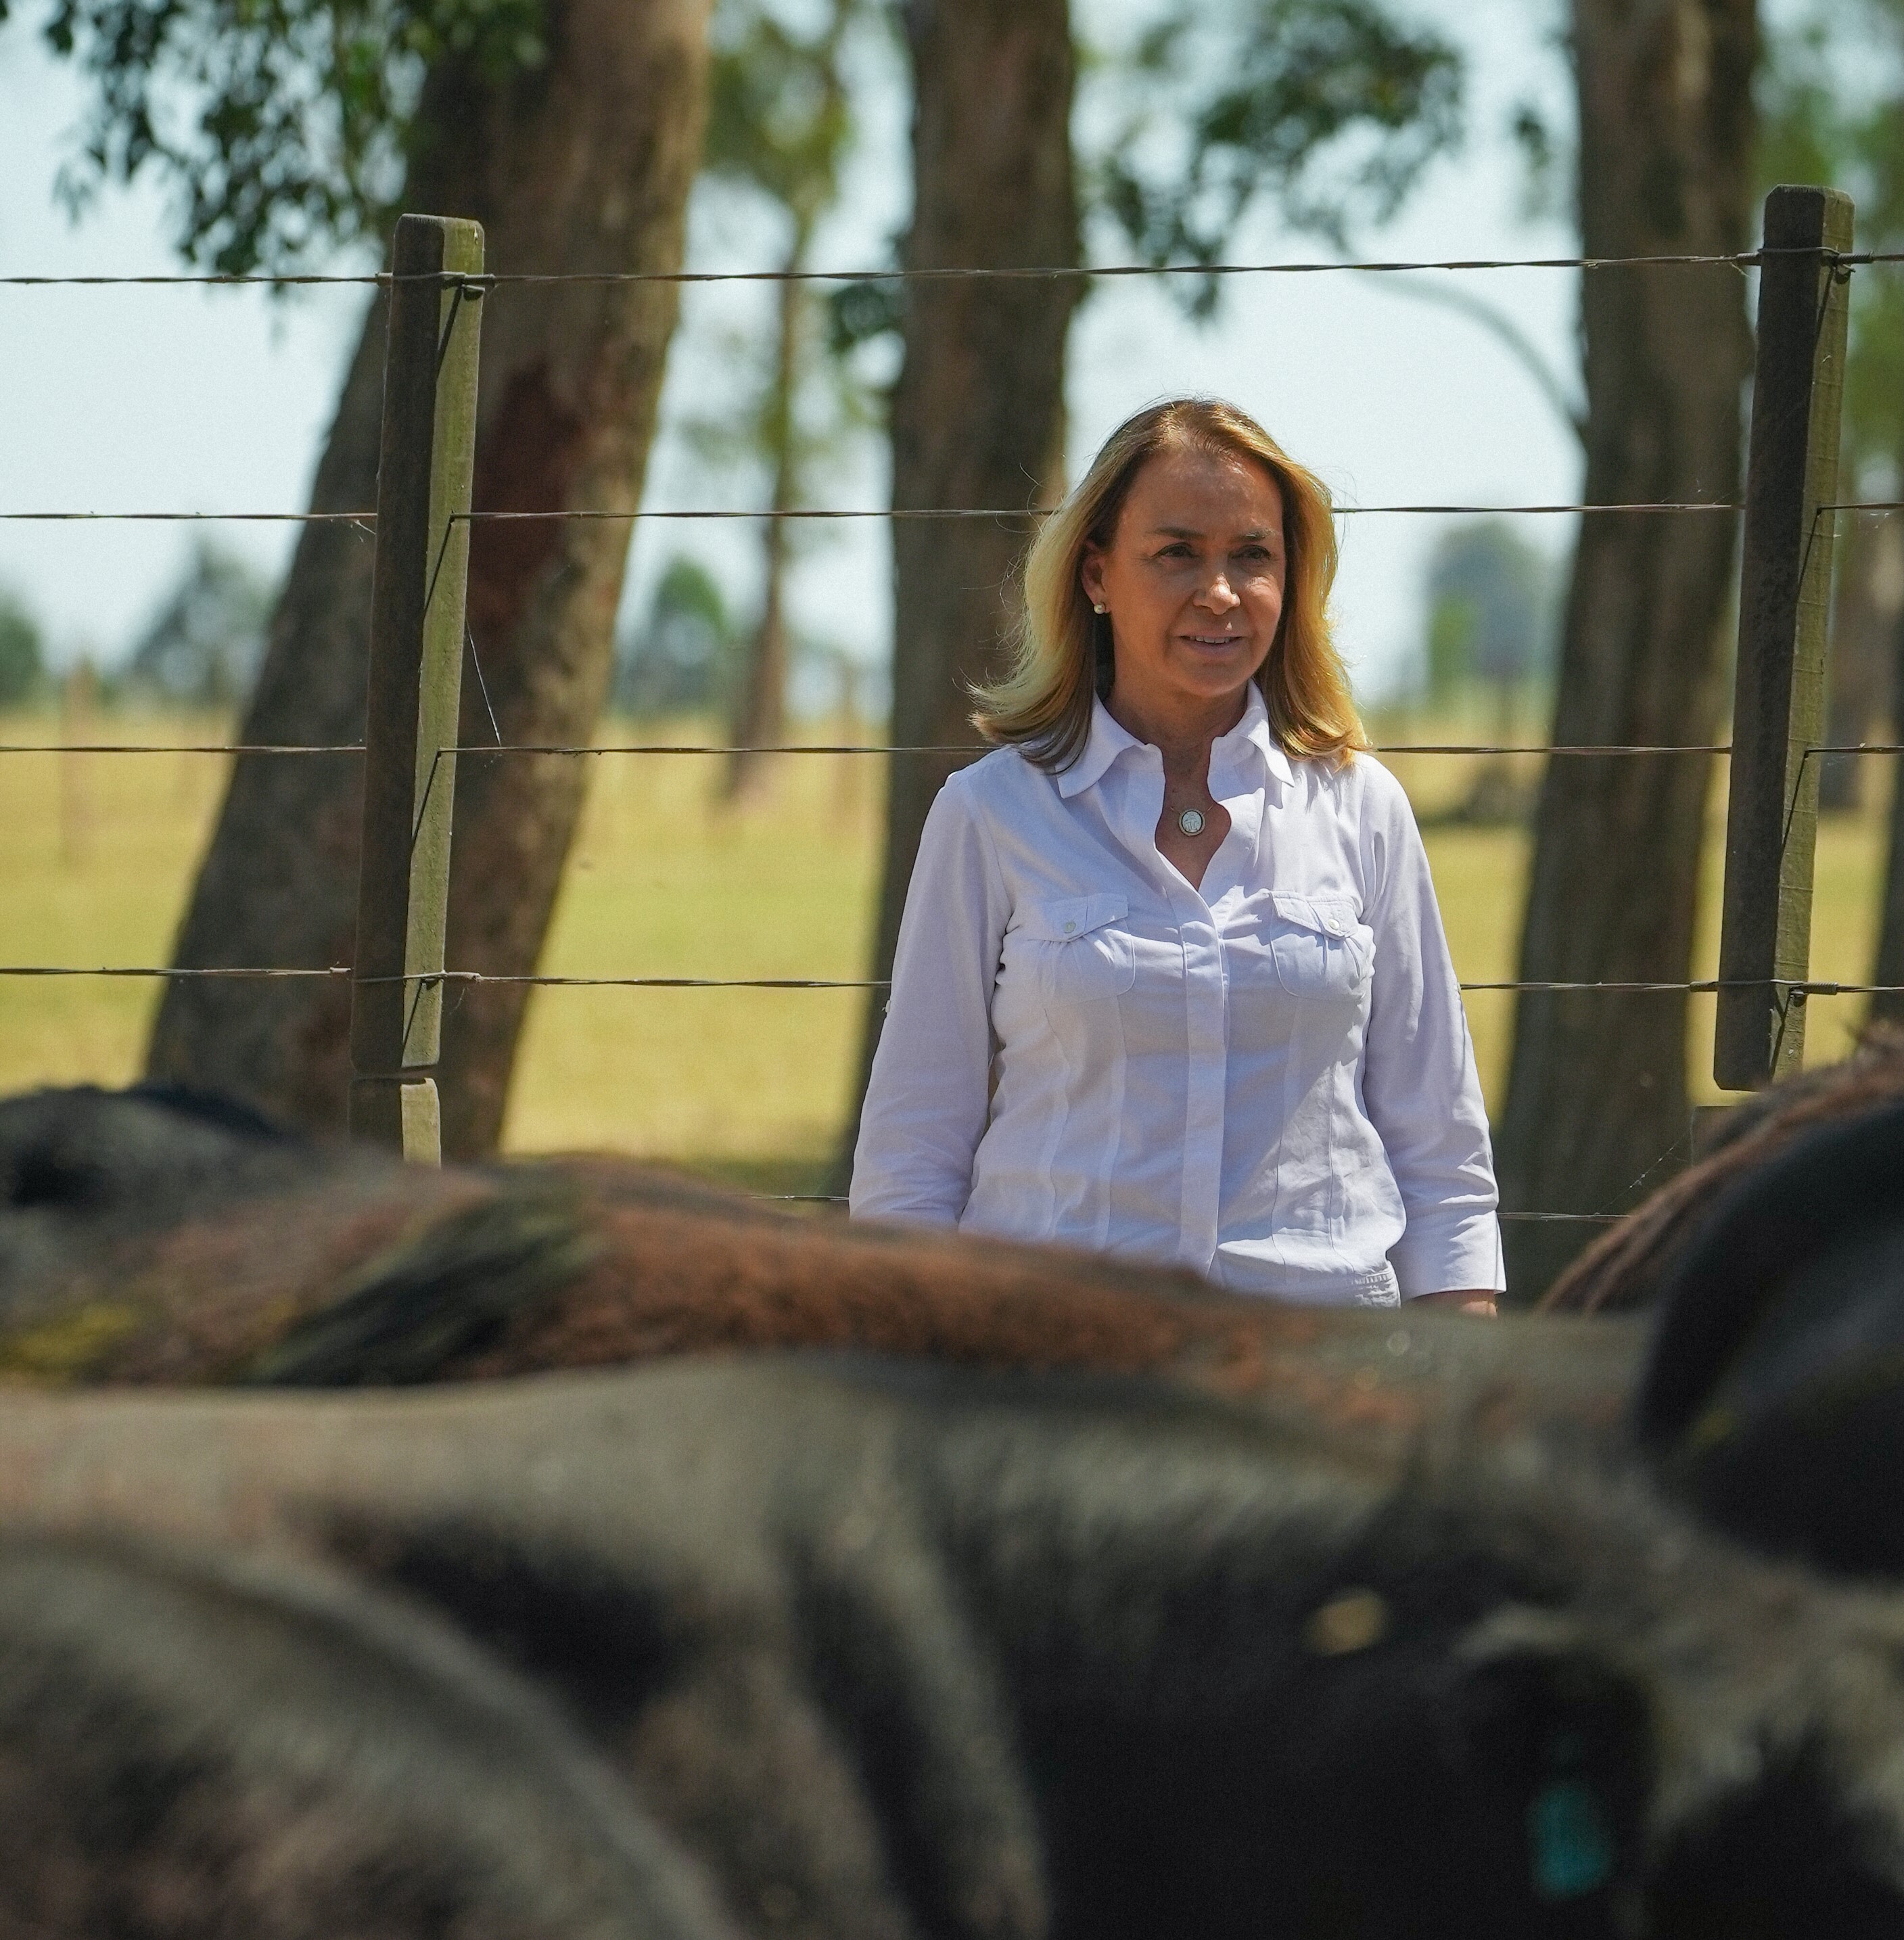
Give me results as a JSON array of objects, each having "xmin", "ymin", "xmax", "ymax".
[{"xmin": 0, "ymin": 0, "xmax": 1807, "ymax": 698}]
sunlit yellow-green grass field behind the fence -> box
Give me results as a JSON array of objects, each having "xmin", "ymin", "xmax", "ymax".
[{"xmin": 0, "ymin": 716, "xmax": 1882, "ymax": 1191}]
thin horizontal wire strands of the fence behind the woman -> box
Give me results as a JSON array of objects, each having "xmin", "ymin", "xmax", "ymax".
[{"xmin": 0, "ymin": 231, "xmax": 1904, "ymax": 1224}]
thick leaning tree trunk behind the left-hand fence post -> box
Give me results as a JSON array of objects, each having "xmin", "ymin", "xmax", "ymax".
[{"xmin": 147, "ymin": 0, "xmax": 705, "ymax": 1154}]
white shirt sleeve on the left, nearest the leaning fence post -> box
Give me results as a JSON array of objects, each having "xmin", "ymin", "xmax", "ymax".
[{"xmin": 851, "ymin": 776, "xmax": 1010, "ymax": 1226}]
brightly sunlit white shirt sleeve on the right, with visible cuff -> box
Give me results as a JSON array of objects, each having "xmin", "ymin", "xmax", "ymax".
[{"xmin": 1357, "ymin": 755, "xmax": 1506, "ymax": 1300}]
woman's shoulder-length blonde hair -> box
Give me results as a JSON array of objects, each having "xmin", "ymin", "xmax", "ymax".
[{"xmin": 971, "ymin": 398, "xmax": 1369, "ymax": 772}]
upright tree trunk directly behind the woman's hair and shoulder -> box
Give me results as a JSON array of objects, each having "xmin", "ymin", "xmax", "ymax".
[{"xmin": 845, "ymin": 0, "xmax": 1080, "ymax": 1158}]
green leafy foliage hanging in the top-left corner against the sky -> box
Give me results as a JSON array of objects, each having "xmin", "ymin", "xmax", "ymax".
[{"xmin": 0, "ymin": 0, "xmax": 545, "ymax": 275}]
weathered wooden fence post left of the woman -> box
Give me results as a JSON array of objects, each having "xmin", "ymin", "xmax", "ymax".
[{"xmin": 351, "ymin": 215, "xmax": 483, "ymax": 1164}]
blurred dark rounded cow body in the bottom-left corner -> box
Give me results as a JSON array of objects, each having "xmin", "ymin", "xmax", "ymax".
[{"xmin": 0, "ymin": 1523, "xmax": 739, "ymax": 1940}]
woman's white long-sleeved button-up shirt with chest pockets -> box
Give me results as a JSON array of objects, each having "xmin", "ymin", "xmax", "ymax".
[{"xmin": 851, "ymin": 683, "xmax": 1504, "ymax": 1306}]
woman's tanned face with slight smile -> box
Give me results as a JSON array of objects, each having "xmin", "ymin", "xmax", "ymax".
[{"xmin": 1082, "ymin": 448, "xmax": 1287, "ymax": 714}]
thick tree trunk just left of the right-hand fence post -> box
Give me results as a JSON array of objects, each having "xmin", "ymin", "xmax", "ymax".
[{"xmin": 1499, "ymin": 0, "xmax": 1759, "ymax": 1300}]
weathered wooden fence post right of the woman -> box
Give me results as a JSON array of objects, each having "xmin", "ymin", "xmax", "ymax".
[{"xmin": 1712, "ymin": 188, "xmax": 1852, "ymax": 1090}]
